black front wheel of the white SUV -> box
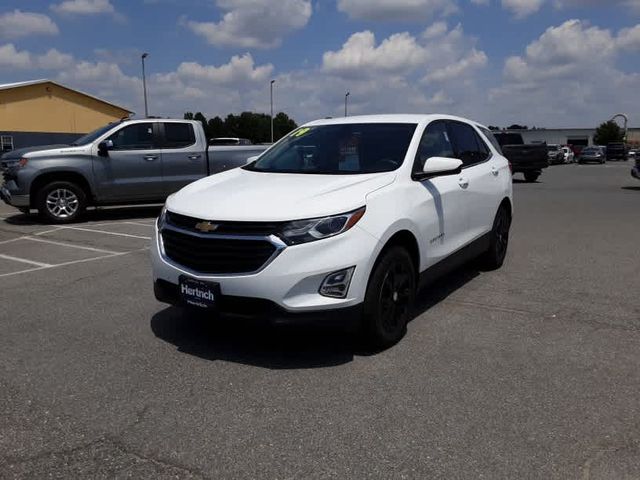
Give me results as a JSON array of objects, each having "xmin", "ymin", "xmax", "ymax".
[{"xmin": 363, "ymin": 247, "xmax": 416, "ymax": 348}]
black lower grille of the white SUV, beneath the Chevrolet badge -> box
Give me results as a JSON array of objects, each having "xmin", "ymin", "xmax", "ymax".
[{"xmin": 162, "ymin": 229, "xmax": 276, "ymax": 274}]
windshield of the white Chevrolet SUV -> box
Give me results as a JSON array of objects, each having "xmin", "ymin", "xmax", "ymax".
[{"xmin": 244, "ymin": 123, "xmax": 416, "ymax": 175}]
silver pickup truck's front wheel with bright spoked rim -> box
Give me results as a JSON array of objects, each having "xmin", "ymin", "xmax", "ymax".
[{"xmin": 36, "ymin": 181, "xmax": 87, "ymax": 223}]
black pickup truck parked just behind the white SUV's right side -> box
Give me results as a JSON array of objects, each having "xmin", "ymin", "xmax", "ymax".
[{"xmin": 489, "ymin": 132, "xmax": 549, "ymax": 182}]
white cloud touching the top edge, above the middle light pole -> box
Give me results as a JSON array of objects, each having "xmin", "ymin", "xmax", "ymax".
[{"xmin": 185, "ymin": 0, "xmax": 311, "ymax": 49}]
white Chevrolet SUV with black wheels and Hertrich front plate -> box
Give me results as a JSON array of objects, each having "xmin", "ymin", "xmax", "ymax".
[{"xmin": 152, "ymin": 115, "xmax": 513, "ymax": 347}]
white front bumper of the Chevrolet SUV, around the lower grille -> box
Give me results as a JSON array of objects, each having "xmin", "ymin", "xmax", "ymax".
[{"xmin": 151, "ymin": 221, "xmax": 378, "ymax": 315}]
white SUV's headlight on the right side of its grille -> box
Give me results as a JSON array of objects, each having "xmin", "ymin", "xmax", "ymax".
[{"xmin": 279, "ymin": 207, "xmax": 366, "ymax": 245}]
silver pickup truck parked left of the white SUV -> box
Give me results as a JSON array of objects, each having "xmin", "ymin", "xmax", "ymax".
[{"xmin": 0, "ymin": 119, "xmax": 267, "ymax": 223}]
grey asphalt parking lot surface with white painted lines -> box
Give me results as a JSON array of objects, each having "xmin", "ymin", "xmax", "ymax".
[{"xmin": 0, "ymin": 163, "xmax": 640, "ymax": 479}]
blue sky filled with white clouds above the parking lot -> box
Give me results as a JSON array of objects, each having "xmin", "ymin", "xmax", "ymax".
[{"xmin": 0, "ymin": 0, "xmax": 640, "ymax": 127}]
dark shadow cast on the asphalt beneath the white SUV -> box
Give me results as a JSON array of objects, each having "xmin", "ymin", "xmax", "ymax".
[{"xmin": 151, "ymin": 264, "xmax": 480, "ymax": 369}]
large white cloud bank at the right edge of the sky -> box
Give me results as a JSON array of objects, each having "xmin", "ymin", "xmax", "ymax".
[{"xmin": 490, "ymin": 20, "xmax": 640, "ymax": 126}]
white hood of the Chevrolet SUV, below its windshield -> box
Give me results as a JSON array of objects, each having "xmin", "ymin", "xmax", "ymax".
[{"xmin": 167, "ymin": 168, "xmax": 396, "ymax": 222}]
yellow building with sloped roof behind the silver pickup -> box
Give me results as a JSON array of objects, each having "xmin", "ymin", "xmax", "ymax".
[{"xmin": 0, "ymin": 80, "xmax": 133, "ymax": 153}]
